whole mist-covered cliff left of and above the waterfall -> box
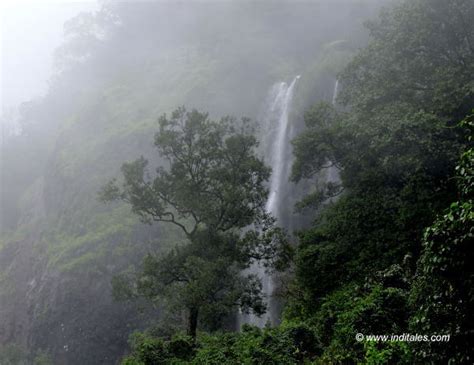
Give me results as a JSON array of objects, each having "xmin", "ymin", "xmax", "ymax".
[{"xmin": 0, "ymin": 2, "xmax": 378, "ymax": 365}]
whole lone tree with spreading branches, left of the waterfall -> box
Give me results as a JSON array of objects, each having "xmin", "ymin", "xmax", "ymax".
[{"xmin": 100, "ymin": 108, "xmax": 285, "ymax": 337}]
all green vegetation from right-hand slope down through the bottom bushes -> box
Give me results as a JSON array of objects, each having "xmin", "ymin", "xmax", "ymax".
[{"xmin": 123, "ymin": 0, "xmax": 474, "ymax": 364}]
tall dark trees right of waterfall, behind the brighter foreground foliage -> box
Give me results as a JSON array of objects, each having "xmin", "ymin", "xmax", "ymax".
[{"xmin": 288, "ymin": 0, "xmax": 474, "ymax": 362}]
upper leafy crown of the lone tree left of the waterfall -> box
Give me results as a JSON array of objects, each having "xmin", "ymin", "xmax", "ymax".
[{"xmin": 101, "ymin": 108, "xmax": 270, "ymax": 235}]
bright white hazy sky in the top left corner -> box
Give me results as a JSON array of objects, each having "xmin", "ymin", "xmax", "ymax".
[{"xmin": 0, "ymin": 0, "xmax": 98, "ymax": 114}]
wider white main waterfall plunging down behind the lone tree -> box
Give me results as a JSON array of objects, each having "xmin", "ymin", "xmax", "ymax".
[{"xmin": 240, "ymin": 76, "xmax": 300, "ymax": 327}]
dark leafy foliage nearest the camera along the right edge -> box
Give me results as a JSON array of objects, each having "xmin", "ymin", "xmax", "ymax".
[{"xmin": 411, "ymin": 115, "xmax": 474, "ymax": 364}]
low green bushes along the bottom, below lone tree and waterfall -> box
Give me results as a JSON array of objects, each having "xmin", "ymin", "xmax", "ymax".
[{"xmin": 122, "ymin": 324, "xmax": 321, "ymax": 365}]
